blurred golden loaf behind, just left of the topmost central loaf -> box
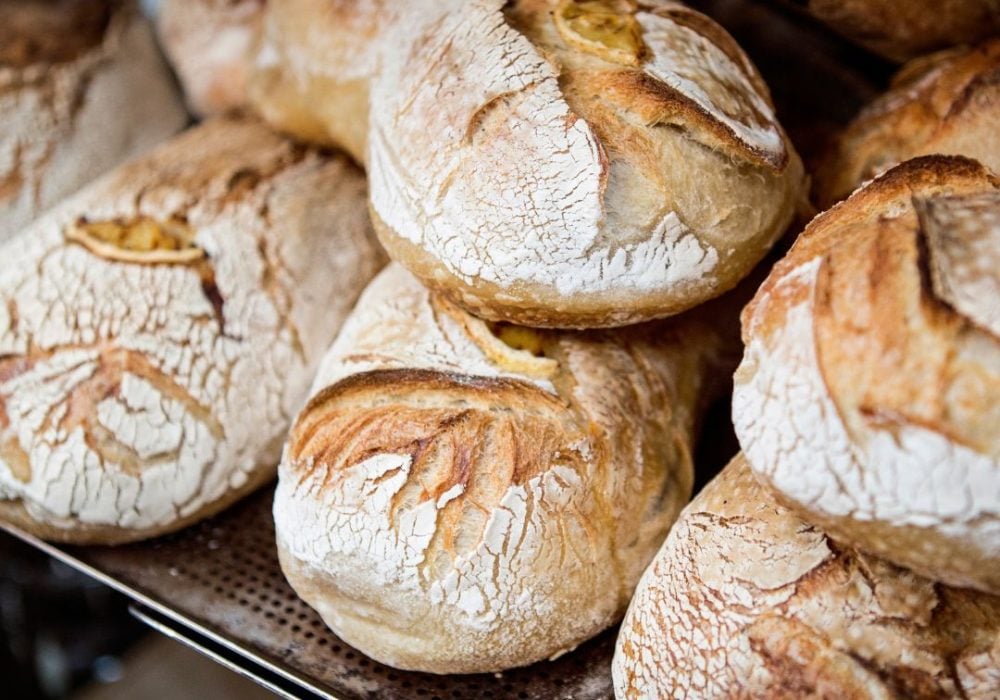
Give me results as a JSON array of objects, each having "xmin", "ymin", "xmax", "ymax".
[{"xmin": 250, "ymin": 0, "xmax": 392, "ymax": 163}]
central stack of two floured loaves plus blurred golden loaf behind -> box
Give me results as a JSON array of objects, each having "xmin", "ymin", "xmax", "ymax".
[{"xmin": 162, "ymin": 0, "xmax": 804, "ymax": 673}]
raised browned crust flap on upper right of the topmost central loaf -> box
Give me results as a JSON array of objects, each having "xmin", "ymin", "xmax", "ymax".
[{"xmin": 548, "ymin": 0, "xmax": 788, "ymax": 170}]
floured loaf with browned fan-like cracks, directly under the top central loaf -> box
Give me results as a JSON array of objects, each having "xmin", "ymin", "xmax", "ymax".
[{"xmin": 274, "ymin": 265, "xmax": 732, "ymax": 673}]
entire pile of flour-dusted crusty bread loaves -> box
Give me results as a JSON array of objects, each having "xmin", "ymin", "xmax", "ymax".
[{"xmin": 0, "ymin": 0, "xmax": 1000, "ymax": 698}]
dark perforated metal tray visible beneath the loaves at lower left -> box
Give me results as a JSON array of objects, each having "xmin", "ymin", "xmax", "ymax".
[{"xmin": 1, "ymin": 488, "xmax": 614, "ymax": 700}]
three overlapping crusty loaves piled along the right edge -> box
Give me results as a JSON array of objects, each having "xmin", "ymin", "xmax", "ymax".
[{"xmin": 614, "ymin": 26, "xmax": 1000, "ymax": 699}]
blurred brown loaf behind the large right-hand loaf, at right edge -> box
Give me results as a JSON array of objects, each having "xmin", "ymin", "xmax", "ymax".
[{"xmin": 814, "ymin": 39, "xmax": 1000, "ymax": 208}]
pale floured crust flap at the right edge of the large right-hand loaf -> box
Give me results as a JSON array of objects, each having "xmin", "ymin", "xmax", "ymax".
[{"xmin": 914, "ymin": 191, "xmax": 1000, "ymax": 337}]
